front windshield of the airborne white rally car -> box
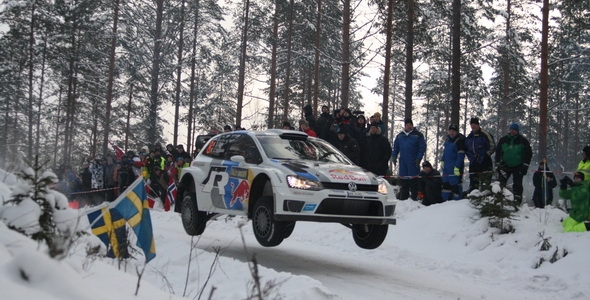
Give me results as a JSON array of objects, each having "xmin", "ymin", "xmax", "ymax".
[{"xmin": 258, "ymin": 136, "xmax": 352, "ymax": 165}]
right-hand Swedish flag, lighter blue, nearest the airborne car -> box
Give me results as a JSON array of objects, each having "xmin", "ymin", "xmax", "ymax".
[{"xmin": 110, "ymin": 177, "xmax": 156, "ymax": 262}]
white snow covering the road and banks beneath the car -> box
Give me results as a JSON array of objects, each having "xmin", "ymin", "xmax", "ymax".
[{"xmin": 0, "ymin": 170, "xmax": 590, "ymax": 300}]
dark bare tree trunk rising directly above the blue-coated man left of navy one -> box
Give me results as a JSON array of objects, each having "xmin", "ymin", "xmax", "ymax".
[{"xmin": 451, "ymin": 0, "xmax": 461, "ymax": 124}]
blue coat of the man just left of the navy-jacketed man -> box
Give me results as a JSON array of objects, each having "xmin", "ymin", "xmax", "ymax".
[{"xmin": 441, "ymin": 133, "xmax": 465, "ymax": 185}]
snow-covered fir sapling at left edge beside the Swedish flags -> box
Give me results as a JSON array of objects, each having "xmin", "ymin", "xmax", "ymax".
[{"xmin": 0, "ymin": 157, "xmax": 84, "ymax": 257}]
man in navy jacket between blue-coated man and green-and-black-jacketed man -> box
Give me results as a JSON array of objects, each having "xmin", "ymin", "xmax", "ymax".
[{"xmin": 465, "ymin": 117, "xmax": 496, "ymax": 194}]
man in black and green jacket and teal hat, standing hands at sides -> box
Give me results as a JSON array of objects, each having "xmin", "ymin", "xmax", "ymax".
[{"xmin": 496, "ymin": 123, "xmax": 533, "ymax": 201}]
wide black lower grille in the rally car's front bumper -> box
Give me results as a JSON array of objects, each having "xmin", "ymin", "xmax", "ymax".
[{"xmin": 315, "ymin": 198, "xmax": 383, "ymax": 217}]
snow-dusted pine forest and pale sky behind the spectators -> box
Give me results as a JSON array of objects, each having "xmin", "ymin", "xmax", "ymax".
[{"xmin": 0, "ymin": 0, "xmax": 590, "ymax": 175}]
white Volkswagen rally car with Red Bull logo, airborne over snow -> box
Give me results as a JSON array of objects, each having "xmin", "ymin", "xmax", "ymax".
[{"xmin": 175, "ymin": 129, "xmax": 396, "ymax": 249}]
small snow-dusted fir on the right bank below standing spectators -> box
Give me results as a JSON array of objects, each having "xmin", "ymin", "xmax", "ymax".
[{"xmin": 467, "ymin": 181, "xmax": 520, "ymax": 233}]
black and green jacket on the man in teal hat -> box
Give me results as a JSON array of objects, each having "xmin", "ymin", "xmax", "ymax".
[{"xmin": 496, "ymin": 134, "xmax": 533, "ymax": 168}]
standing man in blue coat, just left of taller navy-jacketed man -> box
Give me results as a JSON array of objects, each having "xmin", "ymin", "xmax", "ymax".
[{"xmin": 440, "ymin": 124, "xmax": 465, "ymax": 201}]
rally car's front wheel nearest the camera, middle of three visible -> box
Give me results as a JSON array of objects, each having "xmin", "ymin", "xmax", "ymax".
[{"xmin": 252, "ymin": 196, "xmax": 287, "ymax": 247}]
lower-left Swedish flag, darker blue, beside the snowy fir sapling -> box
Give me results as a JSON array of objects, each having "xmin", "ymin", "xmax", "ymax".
[{"xmin": 88, "ymin": 207, "xmax": 128, "ymax": 258}]
